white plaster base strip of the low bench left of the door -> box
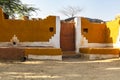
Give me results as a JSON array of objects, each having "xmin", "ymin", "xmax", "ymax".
[{"xmin": 28, "ymin": 55, "xmax": 62, "ymax": 60}]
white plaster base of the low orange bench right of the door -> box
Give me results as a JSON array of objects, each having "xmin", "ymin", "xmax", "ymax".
[{"xmin": 84, "ymin": 54, "xmax": 119, "ymax": 60}]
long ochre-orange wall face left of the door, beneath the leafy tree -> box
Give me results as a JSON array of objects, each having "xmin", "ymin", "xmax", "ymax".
[{"xmin": 0, "ymin": 9, "xmax": 56, "ymax": 42}]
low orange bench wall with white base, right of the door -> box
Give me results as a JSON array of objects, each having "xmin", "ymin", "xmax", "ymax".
[{"xmin": 79, "ymin": 47, "xmax": 120, "ymax": 60}]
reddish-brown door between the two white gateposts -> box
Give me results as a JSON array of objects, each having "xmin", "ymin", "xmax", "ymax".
[{"xmin": 60, "ymin": 22, "xmax": 75, "ymax": 51}]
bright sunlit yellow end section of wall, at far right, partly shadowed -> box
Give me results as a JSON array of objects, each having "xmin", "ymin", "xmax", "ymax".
[{"xmin": 105, "ymin": 19, "xmax": 120, "ymax": 43}]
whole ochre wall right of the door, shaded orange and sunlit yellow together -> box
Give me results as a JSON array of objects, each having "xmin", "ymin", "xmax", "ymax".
[{"xmin": 81, "ymin": 17, "xmax": 120, "ymax": 43}]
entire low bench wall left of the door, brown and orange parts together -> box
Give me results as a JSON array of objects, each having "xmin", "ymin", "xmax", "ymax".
[{"xmin": 0, "ymin": 47, "xmax": 62, "ymax": 60}]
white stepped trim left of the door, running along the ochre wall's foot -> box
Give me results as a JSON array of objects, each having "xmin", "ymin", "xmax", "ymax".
[{"xmin": 0, "ymin": 16, "xmax": 60, "ymax": 48}]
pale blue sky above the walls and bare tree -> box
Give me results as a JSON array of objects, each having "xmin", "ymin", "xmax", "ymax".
[{"xmin": 21, "ymin": 0, "xmax": 120, "ymax": 20}]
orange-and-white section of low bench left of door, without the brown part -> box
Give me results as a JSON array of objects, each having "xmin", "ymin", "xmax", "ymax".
[{"xmin": 25, "ymin": 48, "xmax": 62, "ymax": 60}]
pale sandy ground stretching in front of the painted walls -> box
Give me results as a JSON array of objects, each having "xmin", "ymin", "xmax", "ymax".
[{"xmin": 0, "ymin": 58, "xmax": 120, "ymax": 80}]
